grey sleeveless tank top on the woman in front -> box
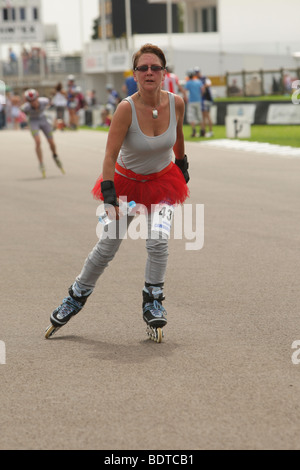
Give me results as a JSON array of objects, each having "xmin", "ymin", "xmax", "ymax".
[{"xmin": 116, "ymin": 92, "xmax": 177, "ymax": 175}]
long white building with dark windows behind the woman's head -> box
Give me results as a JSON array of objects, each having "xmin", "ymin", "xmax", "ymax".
[{"xmin": 84, "ymin": 0, "xmax": 300, "ymax": 99}]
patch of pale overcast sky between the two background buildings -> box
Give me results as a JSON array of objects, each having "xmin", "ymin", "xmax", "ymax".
[{"xmin": 42, "ymin": 0, "xmax": 99, "ymax": 53}]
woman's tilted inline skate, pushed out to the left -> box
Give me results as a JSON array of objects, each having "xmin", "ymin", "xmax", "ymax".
[{"xmin": 45, "ymin": 283, "xmax": 92, "ymax": 339}]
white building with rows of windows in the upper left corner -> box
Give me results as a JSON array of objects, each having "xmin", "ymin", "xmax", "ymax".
[{"xmin": 0, "ymin": 0, "xmax": 73, "ymax": 92}]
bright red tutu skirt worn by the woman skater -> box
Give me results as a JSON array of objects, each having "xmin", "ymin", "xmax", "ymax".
[{"xmin": 92, "ymin": 164, "xmax": 189, "ymax": 208}]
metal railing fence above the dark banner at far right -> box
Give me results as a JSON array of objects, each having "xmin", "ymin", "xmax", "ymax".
[{"xmin": 226, "ymin": 68, "xmax": 300, "ymax": 97}]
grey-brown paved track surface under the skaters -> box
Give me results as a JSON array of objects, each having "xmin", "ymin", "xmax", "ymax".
[{"xmin": 0, "ymin": 126, "xmax": 300, "ymax": 450}]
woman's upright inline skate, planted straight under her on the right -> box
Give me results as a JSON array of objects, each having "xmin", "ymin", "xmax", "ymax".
[{"xmin": 143, "ymin": 283, "xmax": 167, "ymax": 343}]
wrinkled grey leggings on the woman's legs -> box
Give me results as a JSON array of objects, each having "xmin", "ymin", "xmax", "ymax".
[{"xmin": 76, "ymin": 214, "xmax": 169, "ymax": 290}]
